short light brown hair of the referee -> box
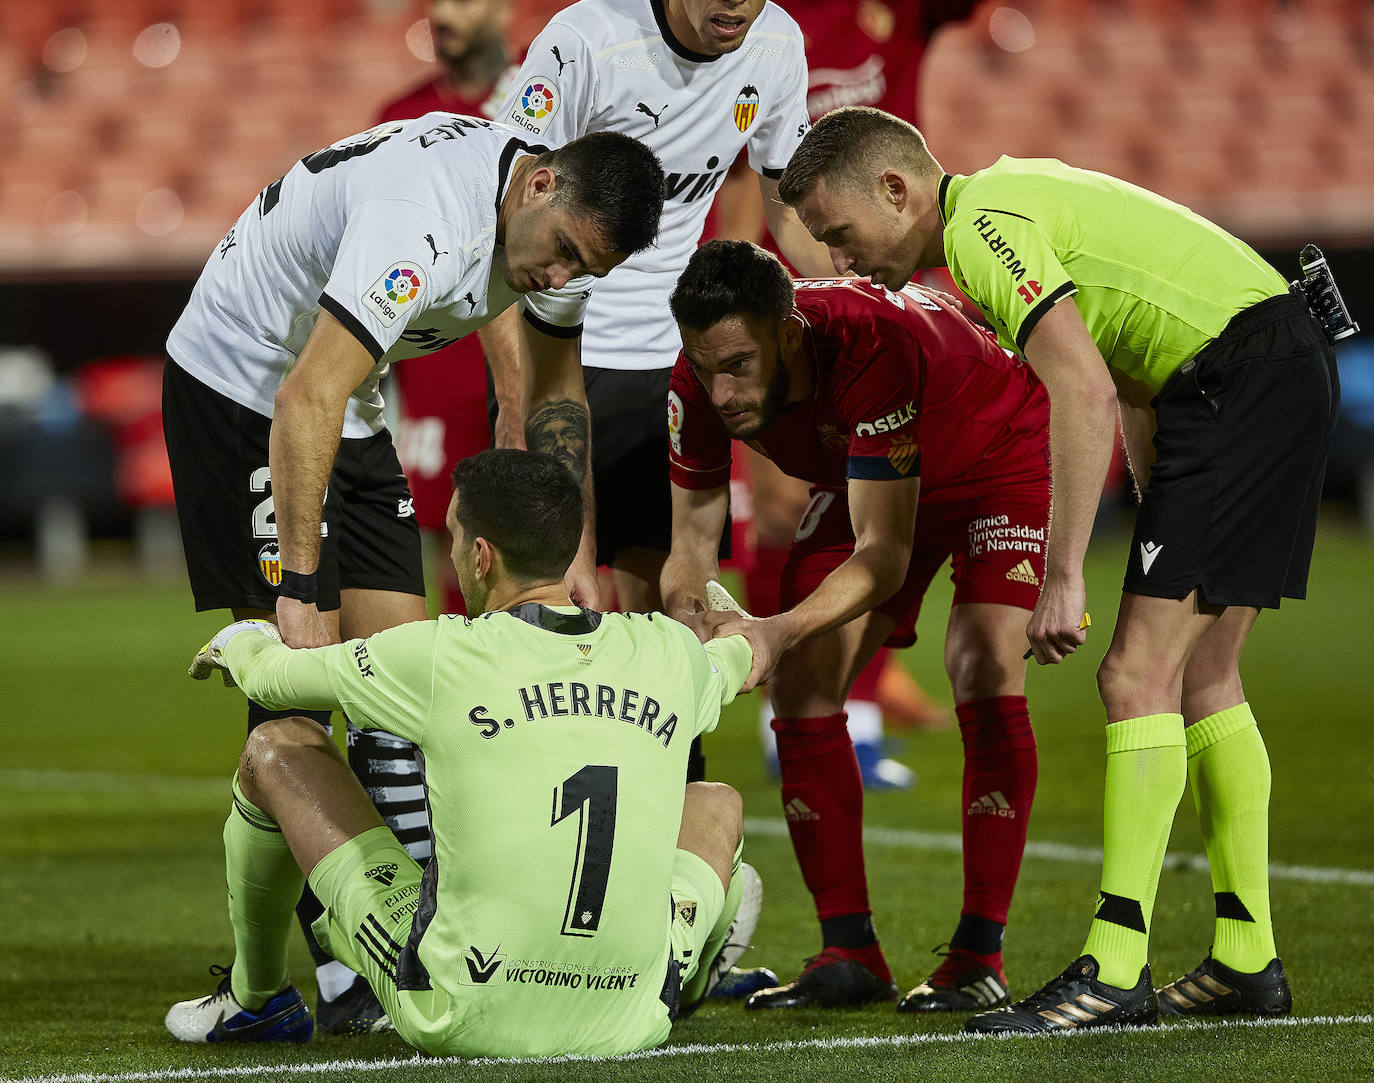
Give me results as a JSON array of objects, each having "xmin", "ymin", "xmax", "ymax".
[{"xmin": 778, "ymin": 106, "xmax": 938, "ymax": 206}]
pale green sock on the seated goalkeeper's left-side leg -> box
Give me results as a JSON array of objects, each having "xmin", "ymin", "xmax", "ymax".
[{"xmin": 224, "ymin": 772, "xmax": 305, "ymax": 1010}]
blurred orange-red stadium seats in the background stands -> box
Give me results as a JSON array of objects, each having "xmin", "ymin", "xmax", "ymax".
[{"xmin": 0, "ymin": 0, "xmax": 1374, "ymax": 275}]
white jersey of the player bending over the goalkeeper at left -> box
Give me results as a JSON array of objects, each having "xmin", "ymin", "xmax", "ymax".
[{"xmin": 168, "ymin": 113, "xmax": 592, "ymax": 437}]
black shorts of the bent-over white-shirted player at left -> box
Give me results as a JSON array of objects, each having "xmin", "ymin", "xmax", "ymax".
[{"xmin": 162, "ymin": 359, "xmax": 425, "ymax": 612}]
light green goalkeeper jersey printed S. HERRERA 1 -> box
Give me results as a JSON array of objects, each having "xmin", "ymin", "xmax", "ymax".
[{"xmin": 224, "ymin": 603, "xmax": 752, "ymax": 1056}]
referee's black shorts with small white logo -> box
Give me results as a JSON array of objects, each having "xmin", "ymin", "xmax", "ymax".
[{"xmin": 1123, "ymin": 294, "xmax": 1340, "ymax": 609}]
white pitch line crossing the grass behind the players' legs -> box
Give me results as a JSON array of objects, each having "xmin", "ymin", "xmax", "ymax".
[{"xmin": 0, "ymin": 770, "xmax": 1374, "ymax": 890}]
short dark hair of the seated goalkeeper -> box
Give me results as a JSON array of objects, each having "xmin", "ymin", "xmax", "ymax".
[{"xmin": 453, "ymin": 448, "xmax": 583, "ymax": 583}]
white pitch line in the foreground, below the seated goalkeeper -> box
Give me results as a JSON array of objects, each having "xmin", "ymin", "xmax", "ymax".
[{"xmin": 0, "ymin": 1016, "xmax": 1374, "ymax": 1083}]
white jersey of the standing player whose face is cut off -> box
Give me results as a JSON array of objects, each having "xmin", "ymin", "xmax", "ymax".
[{"xmin": 496, "ymin": 0, "xmax": 811, "ymax": 368}]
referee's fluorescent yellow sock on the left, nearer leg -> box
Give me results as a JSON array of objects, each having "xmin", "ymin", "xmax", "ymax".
[{"xmin": 1083, "ymin": 715, "xmax": 1187, "ymax": 990}]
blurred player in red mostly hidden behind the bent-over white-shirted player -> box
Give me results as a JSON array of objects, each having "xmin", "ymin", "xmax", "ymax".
[{"xmin": 376, "ymin": 0, "xmax": 510, "ymax": 613}]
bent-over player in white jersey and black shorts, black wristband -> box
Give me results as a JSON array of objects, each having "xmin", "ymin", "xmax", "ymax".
[{"xmin": 164, "ymin": 113, "xmax": 662, "ymax": 1025}]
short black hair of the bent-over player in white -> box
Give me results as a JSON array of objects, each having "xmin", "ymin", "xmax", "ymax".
[{"xmin": 536, "ymin": 132, "xmax": 664, "ymax": 256}]
